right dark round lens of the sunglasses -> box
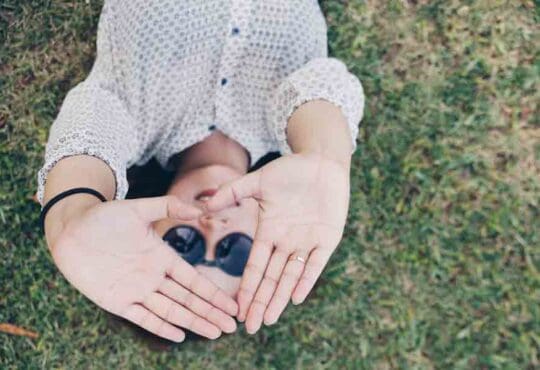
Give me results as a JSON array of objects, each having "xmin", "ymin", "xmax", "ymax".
[{"xmin": 216, "ymin": 233, "xmax": 253, "ymax": 276}]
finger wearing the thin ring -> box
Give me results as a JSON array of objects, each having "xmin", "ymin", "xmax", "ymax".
[{"xmin": 264, "ymin": 251, "xmax": 309, "ymax": 325}]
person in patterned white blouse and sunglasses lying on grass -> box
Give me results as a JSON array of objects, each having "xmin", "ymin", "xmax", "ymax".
[{"xmin": 37, "ymin": 0, "xmax": 364, "ymax": 342}]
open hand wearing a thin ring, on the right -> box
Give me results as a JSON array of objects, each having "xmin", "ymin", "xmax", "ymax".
[{"xmin": 206, "ymin": 154, "xmax": 349, "ymax": 333}]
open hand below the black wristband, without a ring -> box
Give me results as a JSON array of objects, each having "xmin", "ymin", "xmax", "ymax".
[{"xmin": 50, "ymin": 196, "xmax": 237, "ymax": 342}]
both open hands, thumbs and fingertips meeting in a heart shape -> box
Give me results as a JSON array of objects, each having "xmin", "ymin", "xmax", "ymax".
[{"xmin": 47, "ymin": 154, "xmax": 349, "ymax": 342}]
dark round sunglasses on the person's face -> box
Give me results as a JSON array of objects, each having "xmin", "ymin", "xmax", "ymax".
[{"xmin": 163, "ymin": 225, "xmax": 253, "ymax": 276}]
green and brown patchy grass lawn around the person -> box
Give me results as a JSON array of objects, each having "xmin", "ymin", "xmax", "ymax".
[{"xmin": 0, "ymin": 0, "xmax": 540, "ymax": 369}]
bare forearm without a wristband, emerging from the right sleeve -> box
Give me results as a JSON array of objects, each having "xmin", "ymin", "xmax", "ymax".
[{"xmin": 287, "ymin": 99, "xmax": 353, "ymax": 168}]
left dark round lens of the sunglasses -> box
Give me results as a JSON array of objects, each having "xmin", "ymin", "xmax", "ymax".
[{"xmin": 163, "ymin": 226, "xmax": 205, "ymax": 264}]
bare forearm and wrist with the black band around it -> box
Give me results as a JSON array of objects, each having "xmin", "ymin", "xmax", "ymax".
[{"xmin": 43, "ymin": 155, "xmax": 116, "ymax": 249}]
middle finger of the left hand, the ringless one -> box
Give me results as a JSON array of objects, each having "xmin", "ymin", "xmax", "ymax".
[{"xmin": 159, "ymin": 278, "xmax": 236, "ymax": 333}]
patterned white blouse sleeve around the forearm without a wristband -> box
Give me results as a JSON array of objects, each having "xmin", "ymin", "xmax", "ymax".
[{"xmin": 269, "ymin": 57, "xmax": 364, "ymax": 154}]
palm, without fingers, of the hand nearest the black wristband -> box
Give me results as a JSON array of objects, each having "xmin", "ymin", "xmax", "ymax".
[{"xmin": 55, "ymin": 204, "xmax": 175, "ymax": 314}]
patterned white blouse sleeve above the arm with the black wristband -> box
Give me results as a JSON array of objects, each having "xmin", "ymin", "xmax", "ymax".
[{"xmin": 37, "ymin": 2, "xmax": 140, "ymax": 205}]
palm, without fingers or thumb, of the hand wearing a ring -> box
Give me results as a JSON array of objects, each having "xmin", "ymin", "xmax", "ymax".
[{"xmin": 251, "ymin": 155, "xmax": 349, "ymax": 248}]
